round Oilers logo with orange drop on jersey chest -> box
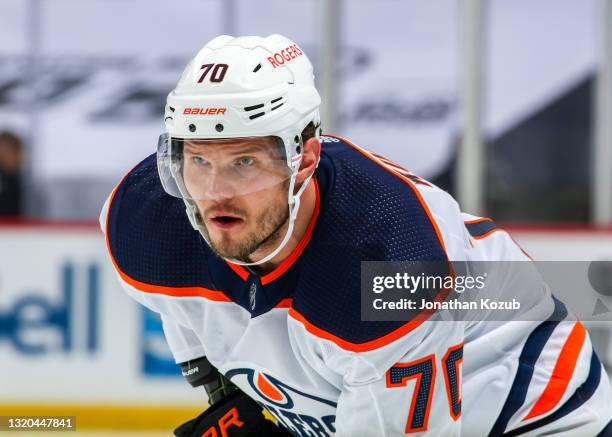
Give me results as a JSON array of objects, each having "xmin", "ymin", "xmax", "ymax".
[{"xmin": 225, "ymin": 368, "xmax": 336, "ymax": 437}]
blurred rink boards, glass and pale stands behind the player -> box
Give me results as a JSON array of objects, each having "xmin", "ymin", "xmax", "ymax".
[{"xmin": 0, "ymin": 0, "xmax": 612, "ymax": 435}]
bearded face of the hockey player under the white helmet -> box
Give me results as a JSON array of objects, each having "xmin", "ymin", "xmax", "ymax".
[{"xmin": 183, "ymin": 138, "xmax": 289, "ymax": 261}]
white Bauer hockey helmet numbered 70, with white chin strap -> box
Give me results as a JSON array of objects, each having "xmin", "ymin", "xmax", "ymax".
[{"xmin": 157, "ymin": 35, "xmax": 321, "ymax": 265}]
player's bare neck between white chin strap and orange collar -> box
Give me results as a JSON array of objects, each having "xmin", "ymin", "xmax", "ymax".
[{"xmin": 251, "ymin": 180, "xmax": 316, "ymax": 275}]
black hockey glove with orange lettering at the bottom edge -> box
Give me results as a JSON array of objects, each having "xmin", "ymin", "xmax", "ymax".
[{"xmin": 174, "ymin": 391, "xmax": 291, "ymax": 437}]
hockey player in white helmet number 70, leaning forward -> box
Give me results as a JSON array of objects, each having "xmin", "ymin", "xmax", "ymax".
[{"xmin": 101, "ymin": 35, "xmax": 612, "ymax": 437}]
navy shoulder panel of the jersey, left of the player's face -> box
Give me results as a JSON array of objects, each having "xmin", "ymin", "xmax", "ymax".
[{"xmin": 107, "ymin": 155, "xmax": 211, "ymax": 288}]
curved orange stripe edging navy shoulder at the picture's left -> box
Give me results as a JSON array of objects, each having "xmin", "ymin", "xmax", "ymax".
[{"xmin": 105, "ymin": 170, "xmax": 232, "ymax": 302}]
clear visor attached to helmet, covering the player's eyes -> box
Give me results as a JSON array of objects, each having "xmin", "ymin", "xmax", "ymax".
[{"xmin": 157, "ymin": 134, "xmax": 291, "ymax": 200}]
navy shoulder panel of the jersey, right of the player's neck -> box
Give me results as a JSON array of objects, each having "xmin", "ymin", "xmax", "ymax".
[{"xmin": 291, "ymin": 137, "xmax": 448, "ymax": 350}]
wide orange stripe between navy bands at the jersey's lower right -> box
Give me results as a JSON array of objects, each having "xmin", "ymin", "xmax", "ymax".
[{"xmin": 523, "ymin": 321, "xmax": 586, "ymax": 421}]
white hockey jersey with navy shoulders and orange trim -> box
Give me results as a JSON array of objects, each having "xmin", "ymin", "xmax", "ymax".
[{"xmin": 101, "ymin": 136, "xmax": 612, "ymax": 436}]
